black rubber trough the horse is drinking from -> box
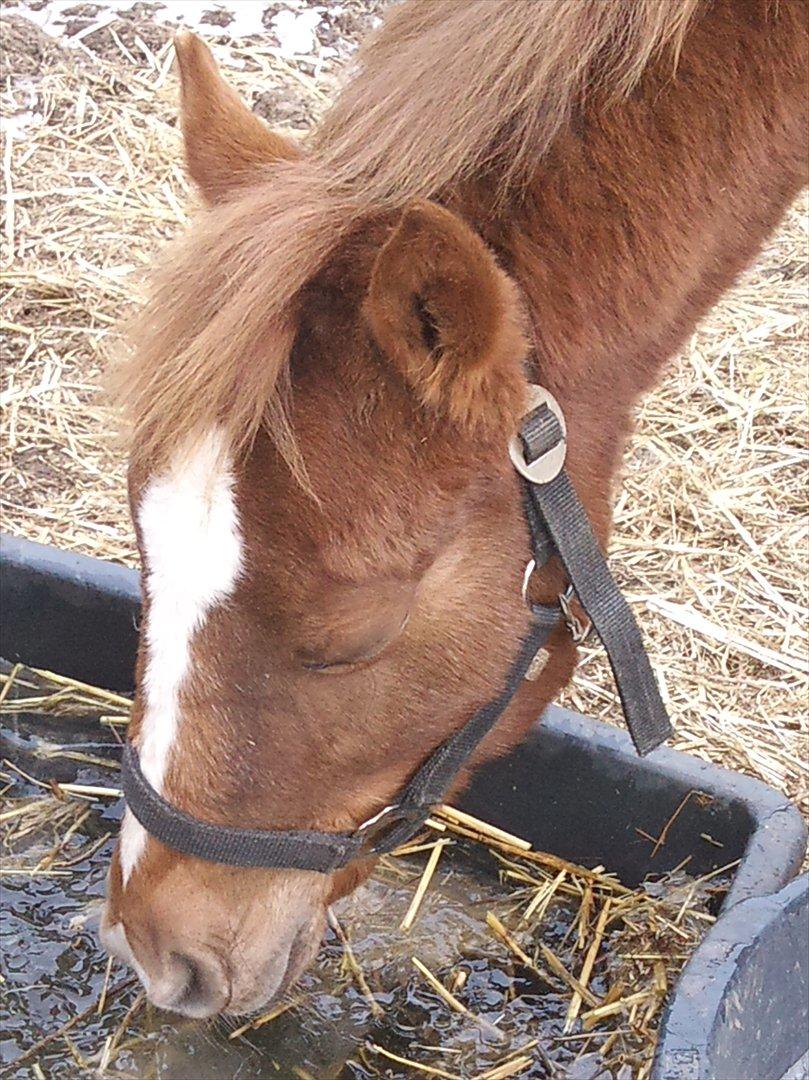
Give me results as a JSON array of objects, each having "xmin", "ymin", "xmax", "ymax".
[{"xmin": 0, "ymin": 536, "xmax": 809, "ymax": 1080}]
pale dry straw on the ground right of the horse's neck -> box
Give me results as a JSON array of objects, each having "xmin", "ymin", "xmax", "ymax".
[{"xmin": 570, "ymin": 198, "xmax": 809, "ymax": 814}]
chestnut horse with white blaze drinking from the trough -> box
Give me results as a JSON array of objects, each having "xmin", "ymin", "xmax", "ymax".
[{"xmin": 103, "ymin": 0, "xmax": 809, "ymax": 1016}]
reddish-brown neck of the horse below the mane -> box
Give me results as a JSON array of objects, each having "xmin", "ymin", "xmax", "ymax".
[{"xmin": 466, "ymin": 0, "xmax": 809, "ymax": 540}]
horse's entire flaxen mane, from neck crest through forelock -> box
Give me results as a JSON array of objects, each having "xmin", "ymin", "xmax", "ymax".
[{"xmin": 113, "ymin": 0, "xmax": 702, "ymax": 474}]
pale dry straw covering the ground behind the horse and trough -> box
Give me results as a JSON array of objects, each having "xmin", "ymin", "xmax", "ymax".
[{"xmin": 0, "ymin": 8, "xmax": 809, "ymax": 813}]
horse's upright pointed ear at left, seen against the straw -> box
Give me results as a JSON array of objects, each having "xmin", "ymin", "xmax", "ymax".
[{"xmin": 174, "ymin": 31, "xmax": 300, "ymax": 203}]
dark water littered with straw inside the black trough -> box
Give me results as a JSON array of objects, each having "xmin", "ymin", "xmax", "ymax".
[{"xmin": 0, "ymin": 669, "xmax": 721, "ymax": 1080}]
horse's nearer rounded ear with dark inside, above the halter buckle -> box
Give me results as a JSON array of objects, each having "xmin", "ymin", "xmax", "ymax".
[{"xmin": 364, "ymin": 201, "xmax": 527, "ymax": 432}]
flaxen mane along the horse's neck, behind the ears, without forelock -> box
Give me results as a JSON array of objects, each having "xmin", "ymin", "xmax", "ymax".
[{"xmin": 313, "ymin": 0, "xmax": 702, "ymax": 202}]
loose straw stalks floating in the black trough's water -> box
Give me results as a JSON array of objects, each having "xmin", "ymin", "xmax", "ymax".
[{"xmin": 0, "ymin": 664, "xmax": 725, "ymax": 1080}]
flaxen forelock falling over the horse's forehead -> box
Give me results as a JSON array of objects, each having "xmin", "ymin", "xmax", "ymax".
[{"xmin": 110, "ymin": 162, "xmax": 356, "ymax": 476}]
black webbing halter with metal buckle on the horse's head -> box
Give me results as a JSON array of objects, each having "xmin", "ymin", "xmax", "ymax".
[{"xmin": 122, "ymin": 387, "xmax": 672, "ymax": 874}]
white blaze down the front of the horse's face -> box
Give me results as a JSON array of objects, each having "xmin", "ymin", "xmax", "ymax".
[{"xmin": 121, "ymin": 431, "xmax": 242, "ymax": 885}]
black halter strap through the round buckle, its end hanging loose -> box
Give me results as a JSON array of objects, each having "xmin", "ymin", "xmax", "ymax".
[{"xmin": 521, "ymin": 405, "xmax": 672, "ymax": 755}]
